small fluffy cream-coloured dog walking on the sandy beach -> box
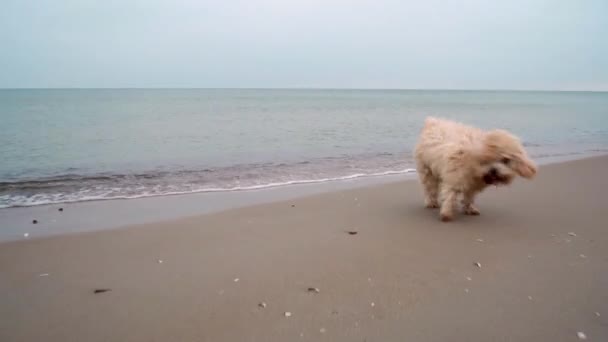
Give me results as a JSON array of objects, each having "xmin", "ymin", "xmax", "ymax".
[{"xmin": 414, "ymin": 117, "xmax": 537, "ymax": 221}]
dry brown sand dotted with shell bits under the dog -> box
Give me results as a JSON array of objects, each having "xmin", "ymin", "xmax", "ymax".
[{"xmin": 0, "ymin": 158, "xmax": 608, "ymax": 342}]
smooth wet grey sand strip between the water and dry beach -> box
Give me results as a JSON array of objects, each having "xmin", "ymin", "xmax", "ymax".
[{"xmin": 0, "ymin": 153, "xmax": 607, "ymax": 243}]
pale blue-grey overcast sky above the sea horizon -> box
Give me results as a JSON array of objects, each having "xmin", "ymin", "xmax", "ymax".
[{"xmin": 0, "ymin": 0, "xmax": 608, "ymax": 90}]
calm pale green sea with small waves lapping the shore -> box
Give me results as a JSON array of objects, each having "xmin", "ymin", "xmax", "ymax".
[{"xmin": 0, "ymin": 89, "xmax": 608, "ymax": 208}]
